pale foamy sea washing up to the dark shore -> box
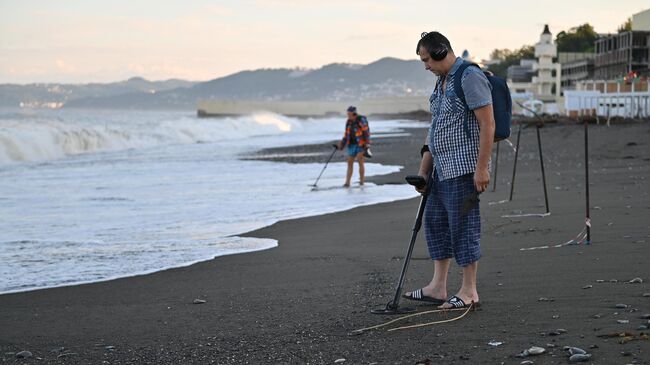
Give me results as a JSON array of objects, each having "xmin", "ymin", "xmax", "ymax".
[{"xmin": 0, "ymin": 109, "xmax": 421, "ymax": 293}]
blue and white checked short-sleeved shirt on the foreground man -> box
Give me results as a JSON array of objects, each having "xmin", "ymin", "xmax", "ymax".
[{"xmin": 427, "ymin": 58, "xmax": 492, "ymax": 180}]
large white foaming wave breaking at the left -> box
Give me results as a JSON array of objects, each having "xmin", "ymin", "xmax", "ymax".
[{"xmin": 0, "ymin": 112, "xmax": 301, "ymax": 164}]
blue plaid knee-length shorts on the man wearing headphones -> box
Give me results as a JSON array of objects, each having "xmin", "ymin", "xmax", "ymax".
[{"xmin": 424, "ymin": 173, "xmax": 481, "ymax": 266}]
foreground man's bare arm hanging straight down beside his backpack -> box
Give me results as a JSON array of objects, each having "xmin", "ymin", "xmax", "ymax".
[{"xmin": 474, "ymin": 104, "xmax": 495, "ymax": 192}]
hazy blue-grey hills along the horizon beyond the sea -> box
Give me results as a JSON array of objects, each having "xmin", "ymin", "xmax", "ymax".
[{"xmin": 0, "ymin": 58, "xmax": 435, "ymax": 109}]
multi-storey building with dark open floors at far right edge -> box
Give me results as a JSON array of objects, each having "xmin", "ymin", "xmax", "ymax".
[{"xmin": 594, "ymin": 9, "xmax": 650, "ymax": 80}]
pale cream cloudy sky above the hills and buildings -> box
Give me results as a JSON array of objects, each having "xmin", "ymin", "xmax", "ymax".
[{"xmin": 0, "ymin": 0, "xmax": 650, "ymax": 84}]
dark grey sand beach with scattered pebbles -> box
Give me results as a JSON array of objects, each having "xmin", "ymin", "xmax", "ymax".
[{"xmin": 0, "ymin": 121, "xmax": 650, "ymax": 364}]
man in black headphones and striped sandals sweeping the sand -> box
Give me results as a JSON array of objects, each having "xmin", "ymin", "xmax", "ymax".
[{"xmin": 404, "ymin": 32, "xmax": 495, "ymax": 308}]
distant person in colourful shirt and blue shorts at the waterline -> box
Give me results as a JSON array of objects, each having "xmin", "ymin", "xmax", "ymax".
[{"xmin": 338, "ymin": 106, "xmax": 370, "ymax": 188}]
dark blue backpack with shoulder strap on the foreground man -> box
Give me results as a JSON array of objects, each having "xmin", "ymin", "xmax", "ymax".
[{"xmin": 454, "ymin": 61, "xmax": 512, "ymax": 141}]
